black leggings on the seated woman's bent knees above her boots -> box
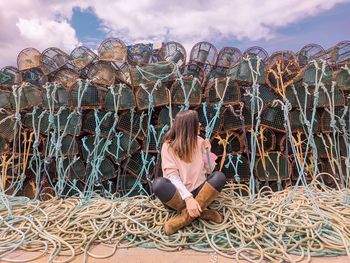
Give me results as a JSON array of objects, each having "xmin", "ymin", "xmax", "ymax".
[{"xmin": 152, "ymin": 171, "xmax": 226, "ymax": 203}]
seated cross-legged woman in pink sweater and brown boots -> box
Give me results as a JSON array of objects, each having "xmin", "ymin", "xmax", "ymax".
[{"xmin": 152, "ymin": 110, "xmax": 226, "ymax": 235}]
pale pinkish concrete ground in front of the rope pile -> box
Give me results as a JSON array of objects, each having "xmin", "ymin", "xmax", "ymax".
[{"xmin": 0, "ymin": 248, "xmax": 350, "ymax": 263}]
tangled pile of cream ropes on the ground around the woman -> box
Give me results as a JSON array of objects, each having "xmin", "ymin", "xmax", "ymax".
[{"xmin": 0, "ymin": 176, "xmax": 350, "ymax": 262}]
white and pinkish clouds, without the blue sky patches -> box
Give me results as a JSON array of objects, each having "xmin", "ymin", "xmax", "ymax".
[{"xmin": 0, "ymin": 0, "xmax": 349, "ymax": 68}]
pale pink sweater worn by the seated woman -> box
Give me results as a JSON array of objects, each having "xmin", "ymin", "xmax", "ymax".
[{"xmin": 161, "ymin": 136, "xmax": 217, "ymax": 192}]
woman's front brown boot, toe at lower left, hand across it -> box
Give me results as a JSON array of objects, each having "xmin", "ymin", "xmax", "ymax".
[{"xmin": 164, "ymin": 182, "xmax": 219, "ymax": 235}]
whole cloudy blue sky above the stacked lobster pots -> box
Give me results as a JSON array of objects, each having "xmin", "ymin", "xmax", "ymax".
[{"xmin": 0, "ymin": 0, "xmax": 350, "ymax": 68}]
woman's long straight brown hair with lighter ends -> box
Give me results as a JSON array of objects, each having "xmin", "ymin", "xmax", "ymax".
[{"xmin": 164, "ymin": 110, "xmax": 199, "ymax": 163}]
